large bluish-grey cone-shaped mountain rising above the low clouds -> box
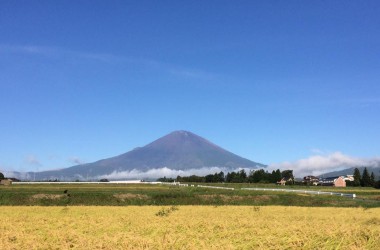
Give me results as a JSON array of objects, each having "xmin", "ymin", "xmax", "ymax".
[{"xmin": 19, "ymin": 131, "xmax": 265, "ymax": 179}]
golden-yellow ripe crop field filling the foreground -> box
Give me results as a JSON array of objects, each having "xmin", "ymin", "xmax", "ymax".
[{"xmin": 0, "ymin": 206, "xmax": 380, "ymax": 249}]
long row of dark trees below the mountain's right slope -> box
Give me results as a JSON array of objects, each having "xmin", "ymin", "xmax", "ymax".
[{"xmin": 158, "ymin": 169, "xmax": 294, "ymax": 183}]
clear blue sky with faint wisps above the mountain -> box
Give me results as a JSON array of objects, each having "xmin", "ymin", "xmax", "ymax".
[{"xmin": 0, "ymin": 0, "xmax": 380, "ymax": 175}]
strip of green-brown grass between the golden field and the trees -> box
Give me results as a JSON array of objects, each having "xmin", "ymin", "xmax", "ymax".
[{"xmin": 0, "ymin": 184, "xmax": 380, "ymax": 208}]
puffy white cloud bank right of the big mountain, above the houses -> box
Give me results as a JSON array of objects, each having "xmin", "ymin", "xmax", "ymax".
[{"xmin": 269, "ymin": 152, "xmax": 380, "ymax": 177}]
